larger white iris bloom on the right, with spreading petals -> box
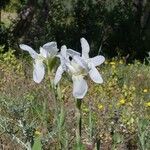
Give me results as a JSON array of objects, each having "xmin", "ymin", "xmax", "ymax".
[{"xmin": 54, "ymin": 38, "xmax": 105, "ymax": 99}]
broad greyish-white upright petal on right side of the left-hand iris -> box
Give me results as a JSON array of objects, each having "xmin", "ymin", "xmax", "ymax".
[{"xmin": 43, "ymin": 42, "xmax": 58, "ymax": 57}]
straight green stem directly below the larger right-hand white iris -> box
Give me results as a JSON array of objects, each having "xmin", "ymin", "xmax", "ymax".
[{"xmin": 76, "ymin": 99, "xmax": 82, "ymax": 150}]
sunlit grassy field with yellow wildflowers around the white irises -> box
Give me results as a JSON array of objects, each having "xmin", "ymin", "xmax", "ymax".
[{"xmin": 0, "ymin": 48, "xmax": 150, "ymax": 150}]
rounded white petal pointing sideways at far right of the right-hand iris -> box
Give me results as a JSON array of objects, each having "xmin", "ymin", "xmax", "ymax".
[{"xmin": 90, "ymin": 55, "xmax": 105, "ymax": 67}]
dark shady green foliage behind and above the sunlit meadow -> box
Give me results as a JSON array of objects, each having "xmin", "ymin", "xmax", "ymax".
[{"xmin": 0, "ymin": 0, "xmax": 150, "ymax": 61}]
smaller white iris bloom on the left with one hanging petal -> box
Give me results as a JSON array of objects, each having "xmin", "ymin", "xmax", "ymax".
[{"xmin": 19, "ymin": 42, "xmax": 58, "ymax": 83}]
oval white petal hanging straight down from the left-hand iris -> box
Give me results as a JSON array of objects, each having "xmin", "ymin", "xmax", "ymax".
[{"xmin": 33, "ymin": 60, "xmax": 45, "ymax": 83}]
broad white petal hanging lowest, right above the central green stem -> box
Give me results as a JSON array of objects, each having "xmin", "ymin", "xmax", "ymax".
[{"xmin": 72, "ymin": 76, "xmax": 88, "ymax": 99}]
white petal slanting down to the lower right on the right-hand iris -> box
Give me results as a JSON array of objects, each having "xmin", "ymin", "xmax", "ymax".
[{"xmin": 89, "ymin": 67, "xmax": 103, "ymax": 83}]
